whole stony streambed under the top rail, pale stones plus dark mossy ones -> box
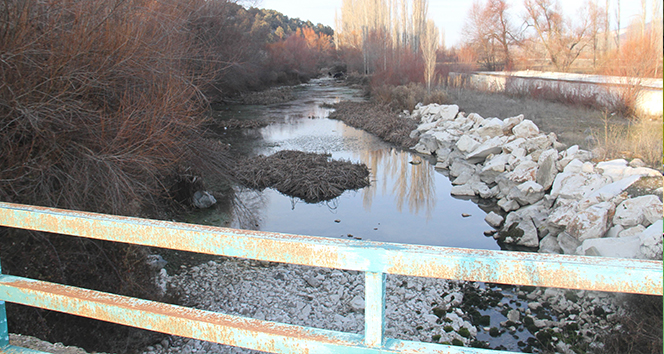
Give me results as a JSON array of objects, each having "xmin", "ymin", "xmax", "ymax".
[{"xmin": 145, "ymin": 258, "xmax": 621, "ymax": 354}]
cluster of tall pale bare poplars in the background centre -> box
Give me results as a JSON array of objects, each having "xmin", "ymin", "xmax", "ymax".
[{"xmin": 335, "ymin": 0, "xmax": 440, "ymax": 87}]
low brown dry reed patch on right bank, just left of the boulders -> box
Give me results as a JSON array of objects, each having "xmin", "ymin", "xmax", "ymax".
[{"xmin": 329, "ymin": 102, "xmax": 417, "ymax": 148}]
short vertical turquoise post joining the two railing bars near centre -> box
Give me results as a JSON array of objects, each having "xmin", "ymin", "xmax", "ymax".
[{"xmin": 364, "ymin": 272, "xmax": 385, "ymax": 348}]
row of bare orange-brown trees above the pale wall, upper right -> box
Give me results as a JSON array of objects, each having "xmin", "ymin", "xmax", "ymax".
[{"xmin": 455, "ymin": 0, "xmax": 662, "ymax": 77}]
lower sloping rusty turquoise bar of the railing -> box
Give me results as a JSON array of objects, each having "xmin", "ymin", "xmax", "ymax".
[{"xmin": 0, "ymin": 275, "xmax": 506, "ymax": 354}]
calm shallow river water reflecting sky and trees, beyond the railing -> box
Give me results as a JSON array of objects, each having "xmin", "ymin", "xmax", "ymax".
[{"xmin": 199, "ymin": 79, "xmax": 500, "ymax": 249}]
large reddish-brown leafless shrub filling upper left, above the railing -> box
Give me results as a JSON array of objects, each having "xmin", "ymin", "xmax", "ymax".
[{"xmin": 0, "ymin": 0, "xmax": 233, "ymax": 214}]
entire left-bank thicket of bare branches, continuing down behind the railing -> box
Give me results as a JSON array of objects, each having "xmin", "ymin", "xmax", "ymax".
[{"xmin": 0, "ymin": 0, "xmax": 338, "ymax": 352}]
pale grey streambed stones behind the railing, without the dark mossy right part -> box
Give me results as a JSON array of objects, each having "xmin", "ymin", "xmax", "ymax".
[{"xmin": 145, "ymin": 258, "xmax": 477, "ymax": 354}]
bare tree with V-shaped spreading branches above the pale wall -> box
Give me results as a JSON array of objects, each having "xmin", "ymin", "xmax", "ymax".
[{"xmin": 524, "ymin": 0, "xmax": 590, "ymax": 71}]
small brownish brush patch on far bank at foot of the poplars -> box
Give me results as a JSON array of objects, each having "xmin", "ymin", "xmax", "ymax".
[{"xmin": 371, "ymin": 83, "xmax": 449, "ymax": 112}]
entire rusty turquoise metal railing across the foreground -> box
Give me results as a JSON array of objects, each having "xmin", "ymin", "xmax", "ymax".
[{"xmin": 0, "ymin": 202, "xmax": 662, "ymax": 353}]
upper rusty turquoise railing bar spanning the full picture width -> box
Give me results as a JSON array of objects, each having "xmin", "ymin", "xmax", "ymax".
[{"xmin": 0, "ymin": 203, "xmax": 662, "ymax": 295}]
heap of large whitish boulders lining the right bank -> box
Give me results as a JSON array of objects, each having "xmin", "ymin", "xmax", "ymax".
[{"xmin": 408, "ymin": 104, "xmax": 662, "ymax": 260}]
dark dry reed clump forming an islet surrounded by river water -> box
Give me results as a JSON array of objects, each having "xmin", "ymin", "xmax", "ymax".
[{"xmin": 235, "ymin": 150, "xmax": 370, "ymax": 203}]
